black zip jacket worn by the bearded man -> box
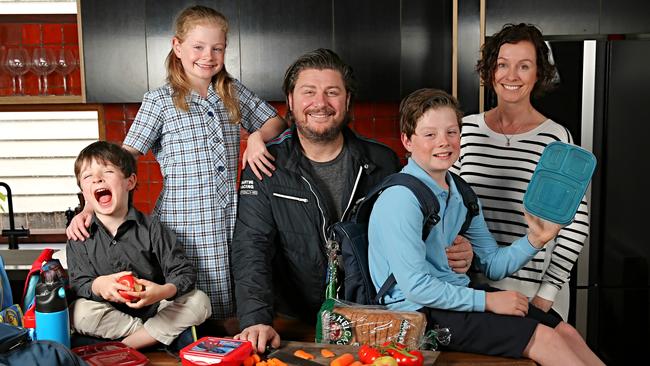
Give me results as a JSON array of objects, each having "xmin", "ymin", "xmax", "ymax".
[{"xmin": 232, "ymin": 127, "xmax": 399, "ymax": 329}]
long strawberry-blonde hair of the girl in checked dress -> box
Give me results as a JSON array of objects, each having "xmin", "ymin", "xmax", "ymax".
[{"xmin": 165, "ymin": 5, "xmax": 241, "ymax": 124}]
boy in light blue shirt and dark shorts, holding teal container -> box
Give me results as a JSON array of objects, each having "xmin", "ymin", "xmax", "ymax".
[{"xmin": 368, "ymin": 89, "xmax": 602, "ymax": 365}]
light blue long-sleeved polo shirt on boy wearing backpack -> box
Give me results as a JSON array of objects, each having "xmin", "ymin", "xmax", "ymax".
[{"xmin": 368, "ymin": 159, "xmax": 538, "ymax": 311}]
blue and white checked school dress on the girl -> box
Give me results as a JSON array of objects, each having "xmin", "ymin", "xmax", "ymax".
[{"xmin": 124, "ymin": 80, "xmax": 277, "ymax": 319}]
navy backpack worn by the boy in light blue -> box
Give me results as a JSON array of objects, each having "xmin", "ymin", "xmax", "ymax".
[{"xmin": 328, "ymin": 172, "xmax": 479, "ymax": 305}]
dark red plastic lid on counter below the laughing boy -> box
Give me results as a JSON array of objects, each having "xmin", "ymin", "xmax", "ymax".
[{"xmin": 72, "ymin": 342, "xmax": 149, "ymax": 366}]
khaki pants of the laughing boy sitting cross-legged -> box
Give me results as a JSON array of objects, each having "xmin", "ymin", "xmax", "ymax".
[{"xmin": 70, "ymin": 289, "xmax": 212, "ymax": 345}]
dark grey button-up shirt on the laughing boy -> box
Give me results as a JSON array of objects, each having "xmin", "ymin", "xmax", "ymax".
[{"xmin": 66, "ymin": 207, "xmax": 196, "ymax": 318}]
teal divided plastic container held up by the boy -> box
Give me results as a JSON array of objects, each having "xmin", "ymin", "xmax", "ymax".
[{"xmin": 524, "ymin": 141, "xmax": 596, "ymax": 225}]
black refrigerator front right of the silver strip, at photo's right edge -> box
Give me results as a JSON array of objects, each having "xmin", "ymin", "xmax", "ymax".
[{"xmin": 587, "ymin": 40, "xmax": 650, "ymax": 365}]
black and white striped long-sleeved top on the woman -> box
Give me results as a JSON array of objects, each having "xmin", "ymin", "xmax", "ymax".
[{"xmin": 451, "ymin": 114, "xmax": 589, "ymax": 319}]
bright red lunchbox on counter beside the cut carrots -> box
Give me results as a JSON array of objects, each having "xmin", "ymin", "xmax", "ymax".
[{"xmin": 180, "ymin": 337, "xmax": 253, "ymax": 366}]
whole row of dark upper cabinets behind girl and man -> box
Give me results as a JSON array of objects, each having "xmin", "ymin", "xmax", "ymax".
[{"xmin": 81, "ymin": 0, "xmax": 452, "ymax": 103}]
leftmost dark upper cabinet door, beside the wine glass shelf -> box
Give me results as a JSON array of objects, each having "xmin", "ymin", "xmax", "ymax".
[{"xmin": 81, "ymin": 0, "xmax": 148, "ymax": 103}]
